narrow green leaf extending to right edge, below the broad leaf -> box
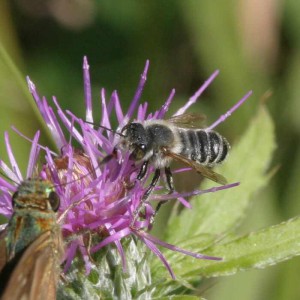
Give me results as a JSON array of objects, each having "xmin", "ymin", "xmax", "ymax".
[{"xmin": 173, "ymin": 217, "xmax": 300, "ymax": 278}]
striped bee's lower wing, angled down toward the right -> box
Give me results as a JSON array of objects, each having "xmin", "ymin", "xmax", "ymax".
[{"xmin": 163, "ymin": 148, "xmax": 227, "ymax": 185}]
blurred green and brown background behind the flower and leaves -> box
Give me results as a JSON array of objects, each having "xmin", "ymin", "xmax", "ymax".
[{"xmin": 0, "ymin": 0, "xmax": 300, "ymax": 300}]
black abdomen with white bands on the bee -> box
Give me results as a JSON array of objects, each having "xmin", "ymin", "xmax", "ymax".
[{"xmin": 179, "ymin": 129, "xmax": 230, "ymax": 167}]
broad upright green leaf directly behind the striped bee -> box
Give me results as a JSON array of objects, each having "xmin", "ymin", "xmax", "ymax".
[{"xmin": 167, "ymin": 106, "xmax": 275, "ymax": 244}]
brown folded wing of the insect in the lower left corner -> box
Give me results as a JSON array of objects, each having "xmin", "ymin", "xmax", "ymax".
[{"xmin": 0, "ymin": 231, "xmax": 62, "ymax": 300}]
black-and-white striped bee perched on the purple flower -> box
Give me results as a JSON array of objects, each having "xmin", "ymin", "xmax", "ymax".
[{"xmin": 96, "ymin": 114, "xmax": 230, "ymax": 223}]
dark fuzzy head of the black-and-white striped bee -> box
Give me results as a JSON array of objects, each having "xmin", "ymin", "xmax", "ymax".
[{"xmin": 121, "ymin": 123, "xmax": 149, "ymax": 161}]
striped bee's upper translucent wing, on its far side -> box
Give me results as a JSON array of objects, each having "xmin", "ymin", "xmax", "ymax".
[{"xmin": 167, "ymin": 113, "xmax": 206, "ymax": 128}]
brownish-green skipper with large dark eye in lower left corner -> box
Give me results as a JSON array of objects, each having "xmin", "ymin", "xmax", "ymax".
[{"xmin": 0, "ymin": 179, "xmax": 64, "ymax": 300}]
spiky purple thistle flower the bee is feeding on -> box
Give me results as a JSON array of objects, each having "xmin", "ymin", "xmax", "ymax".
[{"xmin": 0, "ymin": 57, "xmax": 251, "ymax": 278}]
